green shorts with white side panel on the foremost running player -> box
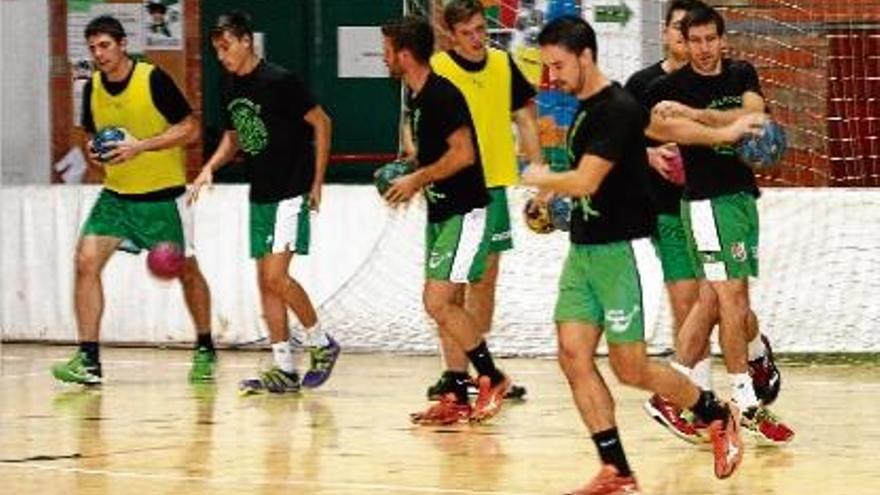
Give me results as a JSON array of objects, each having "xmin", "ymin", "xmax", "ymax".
[{"xmin": 554, "ymin": 238, "xmax": 663, "ymax": 344}]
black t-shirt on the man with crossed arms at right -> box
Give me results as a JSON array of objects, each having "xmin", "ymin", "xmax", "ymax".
[{"xmin": 648, "ymin": 59, "xmax": 761, "ymax": 199}]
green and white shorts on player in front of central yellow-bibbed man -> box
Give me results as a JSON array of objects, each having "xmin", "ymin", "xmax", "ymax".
[{"xmin": 425, "ymin": 208, "xmax": 491, "ymax": 284}]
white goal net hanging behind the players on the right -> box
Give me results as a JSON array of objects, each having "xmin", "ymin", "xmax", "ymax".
[{"xmin": 321, "ymin": 0, "xmax": 880, "ymax": 354}]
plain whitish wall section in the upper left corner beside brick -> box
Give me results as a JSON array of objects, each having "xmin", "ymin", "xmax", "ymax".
[{"xmin": 0, "ymin": 0, "xmax": 51, "ymax": 185}]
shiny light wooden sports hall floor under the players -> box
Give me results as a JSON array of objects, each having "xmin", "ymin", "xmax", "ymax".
[{"xmin": 0, "ymin": 344, "xmax": 880, "ymax": 495}]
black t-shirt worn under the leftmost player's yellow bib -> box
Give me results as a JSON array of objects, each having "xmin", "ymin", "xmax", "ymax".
[{"xmin": 80, "ymin": 60, "xmax": 192, "ymax": 134}]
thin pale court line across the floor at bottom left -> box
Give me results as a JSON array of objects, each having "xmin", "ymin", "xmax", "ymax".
[{"xmin": 0, "ymin": 462, "xmax": 536, "ymax": 495}]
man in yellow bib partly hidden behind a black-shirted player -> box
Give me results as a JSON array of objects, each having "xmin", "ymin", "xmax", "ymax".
[{"xmin": 428, "ymin": 0, "xmax": 543, "ymax": 399}]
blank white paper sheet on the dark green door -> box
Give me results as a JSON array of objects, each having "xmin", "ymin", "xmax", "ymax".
[{"xmin": 337, "ymin": 26, "xmax": 388, "ymax": 78}]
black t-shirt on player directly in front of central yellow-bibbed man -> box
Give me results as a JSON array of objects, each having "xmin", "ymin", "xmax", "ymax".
[{"xmin": 407, "ymin": 72, "xmax": 489, "ymax": 223}]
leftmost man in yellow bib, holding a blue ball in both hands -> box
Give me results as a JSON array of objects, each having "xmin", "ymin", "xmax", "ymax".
[{"xmin": 52, "ymin": 16, "xmax": 216, "ymax": 385}]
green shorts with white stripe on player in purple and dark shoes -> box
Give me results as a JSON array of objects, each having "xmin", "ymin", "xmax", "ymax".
[{"xmin": 250, "ymin": 194, "xmax": 311, "ymax": 259}]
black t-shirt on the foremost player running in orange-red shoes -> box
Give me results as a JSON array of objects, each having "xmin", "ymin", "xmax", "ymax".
[{"xmin": 567, "ymin": 83, "xmax": 656, "ymax": 244}]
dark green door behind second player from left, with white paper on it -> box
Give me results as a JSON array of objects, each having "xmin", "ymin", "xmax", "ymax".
[{"xmin": 201, "ymin": 0, "xmax": 402, "ymax": 182}]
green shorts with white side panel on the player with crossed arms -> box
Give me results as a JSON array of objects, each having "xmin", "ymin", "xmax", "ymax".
[{"xmin": 681, "ymin": 192, "xmax": 758, "ymax": 281}]
